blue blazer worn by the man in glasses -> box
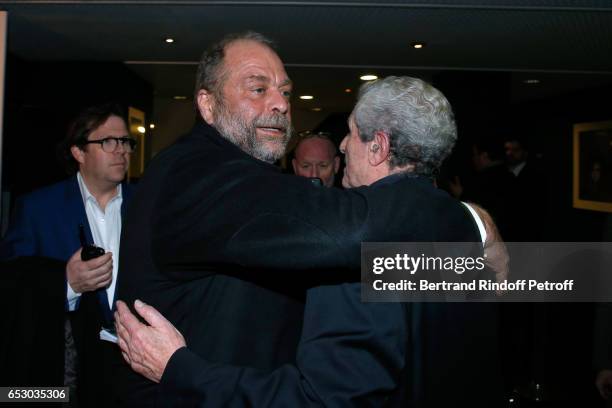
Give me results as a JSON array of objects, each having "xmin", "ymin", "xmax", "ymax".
[{"xmin": 0, "ymin": 175, "xmax": 132, "ymax": 310}]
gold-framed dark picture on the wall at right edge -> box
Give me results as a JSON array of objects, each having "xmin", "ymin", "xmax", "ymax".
[{"xmin": 573, "ymin": 120, "xmax": 612, "ymax": 212}]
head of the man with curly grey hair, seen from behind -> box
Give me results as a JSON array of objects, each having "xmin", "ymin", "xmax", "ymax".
[{"xmin": 340, "ymin": 76, "xmax": 457, "ymax": 187}]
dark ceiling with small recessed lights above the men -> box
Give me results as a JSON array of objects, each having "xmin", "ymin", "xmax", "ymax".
[{"xmin": 0, "ymin": 0, "xmax": 612, "ymax": 124}]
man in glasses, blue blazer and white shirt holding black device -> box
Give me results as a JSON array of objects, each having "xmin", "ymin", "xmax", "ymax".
[{"xmin": 0, "ymin": 104, "xmax": 136, "ymax": 407}]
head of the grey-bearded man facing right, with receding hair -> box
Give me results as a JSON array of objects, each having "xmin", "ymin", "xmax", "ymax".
[{"xmin": 196, "ymin": 33, "xmax": 292, "ymax": 163}]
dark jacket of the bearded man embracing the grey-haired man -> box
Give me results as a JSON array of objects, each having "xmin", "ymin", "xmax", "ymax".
[{"xmin": 117, "ymin": 125, "xmax": 502, "ymax": 406}]
